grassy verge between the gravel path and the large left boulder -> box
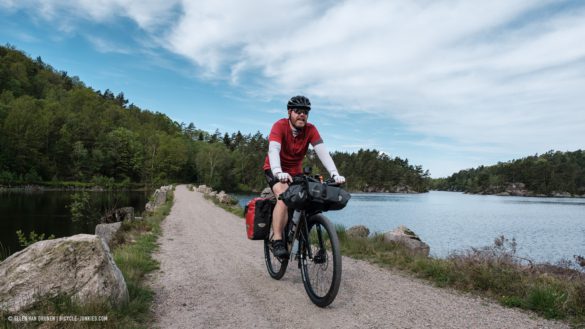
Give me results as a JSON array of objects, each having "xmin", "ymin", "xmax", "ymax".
[{"xmin": 0, "ymin": 188, "xmax": 173, "ymax": 329}]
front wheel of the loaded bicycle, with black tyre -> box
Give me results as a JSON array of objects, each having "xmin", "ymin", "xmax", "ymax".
[{"xmin": 301, "ymin": 214, "xmax": 341, "ymax": 307}]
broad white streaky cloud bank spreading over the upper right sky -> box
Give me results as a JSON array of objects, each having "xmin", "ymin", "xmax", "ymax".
[{"xmin": 5, "ymin": 0, "xmax": 585, "ymax": 174}]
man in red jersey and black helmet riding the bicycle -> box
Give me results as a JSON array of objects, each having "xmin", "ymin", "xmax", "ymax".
[{"xmin": 263, "ymin": 96, "xmax": 345, "ymax": 257}]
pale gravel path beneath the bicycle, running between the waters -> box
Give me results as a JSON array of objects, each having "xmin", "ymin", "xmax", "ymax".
[{"xmin": 152, "ymin": 186, "xmax": 568, "ymax": 329}]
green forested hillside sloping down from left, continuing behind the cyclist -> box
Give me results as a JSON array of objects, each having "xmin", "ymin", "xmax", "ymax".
[{"xmin": 0, "ymin": 45, "xmax": 430, "ymax": 192}]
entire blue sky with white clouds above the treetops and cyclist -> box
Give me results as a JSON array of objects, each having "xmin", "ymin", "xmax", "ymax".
[{"xmin": 0, "ymin": 0, "xmax": 585, "ymax": 177}]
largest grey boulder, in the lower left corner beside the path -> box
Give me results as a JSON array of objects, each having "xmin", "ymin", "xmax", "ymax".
[{"xmin": 0, "ymin": 234, "xmax": 128, "ymax": 313}]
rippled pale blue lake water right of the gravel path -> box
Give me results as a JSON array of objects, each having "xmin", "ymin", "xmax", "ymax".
[{"xmin": 235, "ymin": 191, "xmax": 585, "ymax": 263}]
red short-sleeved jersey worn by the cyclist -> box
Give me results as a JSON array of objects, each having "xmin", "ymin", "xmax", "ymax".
[{"xmin": 264, "ymin": 119, "xmax": 323, "ymax": 176}]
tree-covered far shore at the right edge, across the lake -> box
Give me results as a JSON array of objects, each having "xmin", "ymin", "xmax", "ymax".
[{"xmin": 433, "ymin": 150, "xmax": 585, "ymax": 195}]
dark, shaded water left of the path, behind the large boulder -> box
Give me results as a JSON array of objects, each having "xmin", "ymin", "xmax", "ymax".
[{"xmin": 0, "ymin": 191, "xmax": 149, "ymax": 253}]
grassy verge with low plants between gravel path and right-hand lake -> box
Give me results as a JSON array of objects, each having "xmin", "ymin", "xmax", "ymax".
[{"xmin": 336, "ymin": 225, "xmax": 585, "ymax": 327}]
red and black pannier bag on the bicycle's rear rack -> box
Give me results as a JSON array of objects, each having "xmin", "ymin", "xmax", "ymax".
[{"xmin": 244, "ymin": 198, "xmax": 276, "ymax": 240}]
